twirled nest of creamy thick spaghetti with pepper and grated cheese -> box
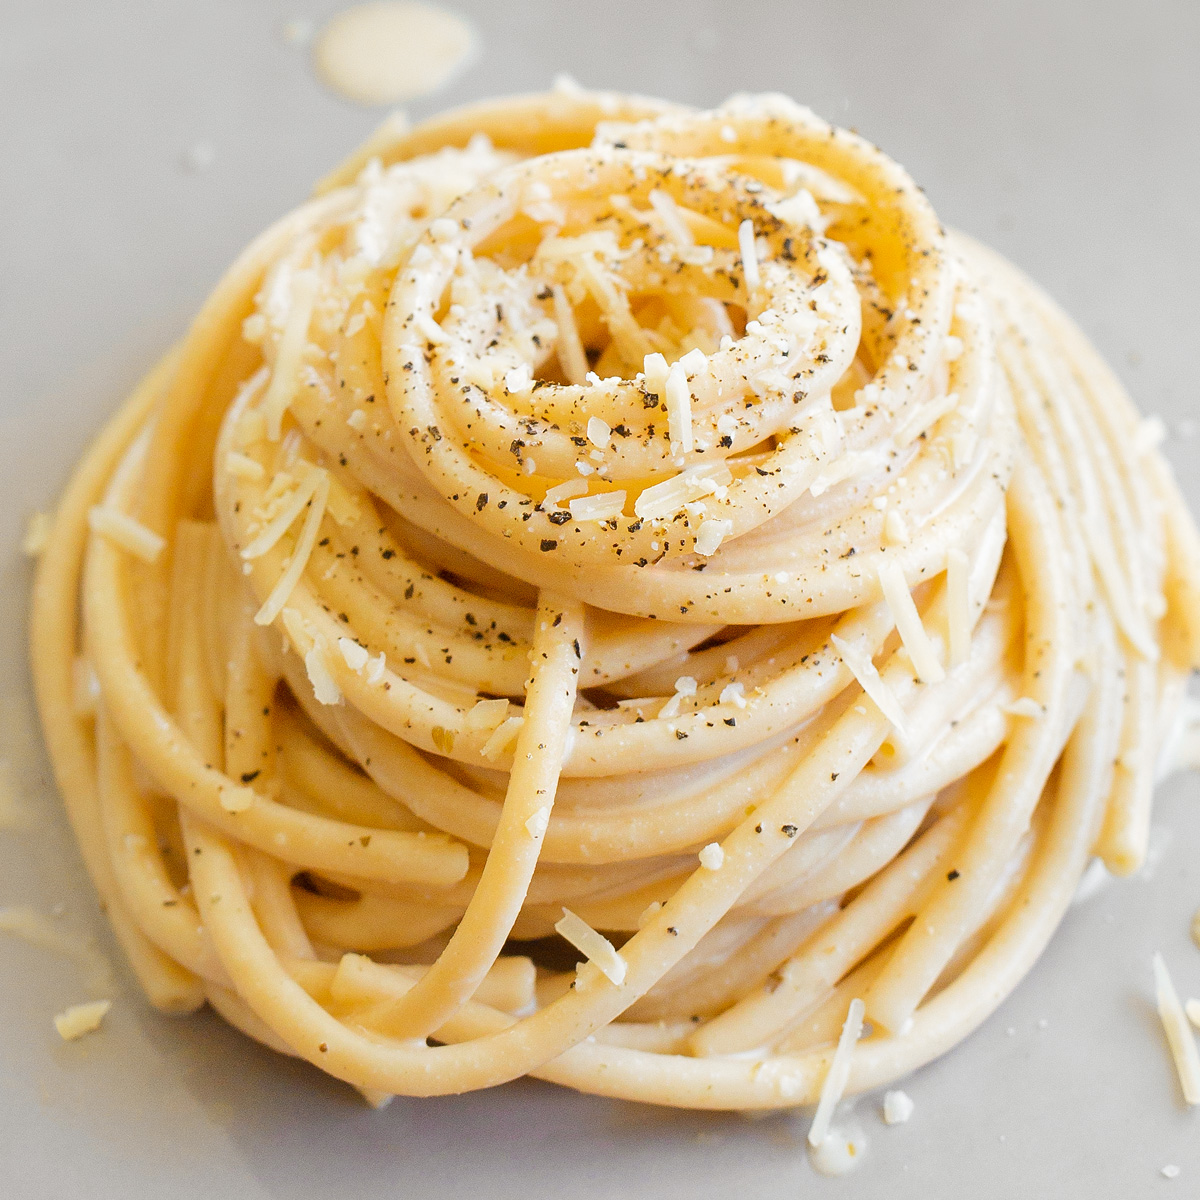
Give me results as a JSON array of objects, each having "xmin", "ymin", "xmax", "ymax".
[{"xmin": 31, "ymin": 94, "xmax": 1200, "ymax": 1109}]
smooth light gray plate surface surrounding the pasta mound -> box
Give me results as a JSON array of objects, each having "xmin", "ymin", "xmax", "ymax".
[{"xmin": 0, "ymin": 0, "xmax": 1200, "ymax": 1200}]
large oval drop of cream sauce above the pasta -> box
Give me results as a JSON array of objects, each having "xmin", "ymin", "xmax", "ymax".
[{"xmin": 312, "ymin": 0, "xmax": 476, "ymax": 104}]
